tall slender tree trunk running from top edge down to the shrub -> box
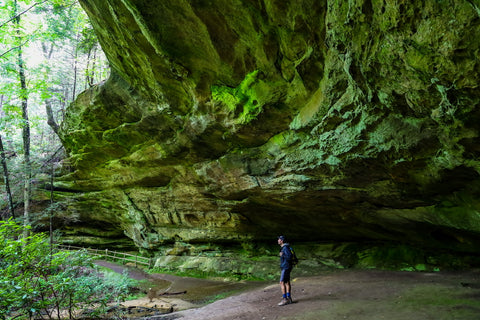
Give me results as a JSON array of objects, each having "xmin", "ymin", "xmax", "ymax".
[{"xmin": 14, "ymin": 1, "xmax": 32, "ymax": 237}]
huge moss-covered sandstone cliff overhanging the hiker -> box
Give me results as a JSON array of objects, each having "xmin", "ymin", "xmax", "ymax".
[{"xmin": 57, "ymin": 0, "xmax": 480, "ymax": 268}]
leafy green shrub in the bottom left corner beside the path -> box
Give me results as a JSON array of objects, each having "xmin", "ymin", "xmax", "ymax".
[{"xmin": 0, "ymin": 220, "xmax": 131, "ymax": 319}]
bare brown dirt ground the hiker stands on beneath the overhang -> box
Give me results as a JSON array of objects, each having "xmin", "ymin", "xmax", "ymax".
[{"xmin": 96, "ymin": 262, "xmax": 480, "ymax": 320}]
